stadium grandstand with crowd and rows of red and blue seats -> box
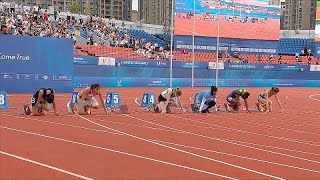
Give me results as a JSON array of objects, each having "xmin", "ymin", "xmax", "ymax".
[{"xmin": 0, "ymin": 1, "xmax": 319, "ymax": 64}]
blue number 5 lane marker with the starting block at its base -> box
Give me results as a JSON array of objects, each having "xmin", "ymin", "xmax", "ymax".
[{"xmin": 105, "ymin": 92, "xmax": 130, "ymax": 114}]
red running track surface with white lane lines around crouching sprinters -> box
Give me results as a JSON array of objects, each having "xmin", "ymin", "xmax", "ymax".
[{"xmin": 0, "ymin": 88, "xmax": 320, "ymax": 179}]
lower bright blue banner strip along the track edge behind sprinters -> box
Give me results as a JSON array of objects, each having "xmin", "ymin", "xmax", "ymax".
[{"xmin": 74, "ymin": 77, "xmax": 320, "ymax": 88}]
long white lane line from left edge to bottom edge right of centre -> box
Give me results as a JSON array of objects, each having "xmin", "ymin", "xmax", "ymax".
[{"xmin": 0, "ymin": 126, "xmax": 236, "ymax": 180}]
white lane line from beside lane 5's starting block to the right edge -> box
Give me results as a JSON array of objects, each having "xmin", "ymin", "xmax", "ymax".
[{"xmin": 124, "ymin": 114, "xmax": 320, "ymax": 164}]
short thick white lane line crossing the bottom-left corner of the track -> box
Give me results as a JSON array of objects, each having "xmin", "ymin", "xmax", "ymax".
[{"xmin": 0, "ymin": 151, "xmax": 93, "ymax": 180}]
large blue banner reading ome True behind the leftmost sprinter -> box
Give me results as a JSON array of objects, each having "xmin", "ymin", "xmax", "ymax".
[{"xmin": 0, "ymin": 36, "xmax": 74, "ymax": 93}]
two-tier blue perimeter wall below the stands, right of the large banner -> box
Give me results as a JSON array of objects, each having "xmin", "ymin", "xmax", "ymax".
[{"xmin": 74, "ymin": 57, "xmax": 320, "ymax": 87}]
